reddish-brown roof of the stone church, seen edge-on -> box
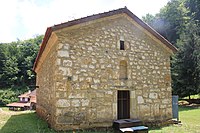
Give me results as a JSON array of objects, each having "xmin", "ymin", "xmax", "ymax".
[{"xmin": 33, "ymin": 7, "xmax": 177, "ymax": 70}]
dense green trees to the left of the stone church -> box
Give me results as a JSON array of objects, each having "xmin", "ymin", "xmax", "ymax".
[{"xmin": 0, "ymin": 36, "xmax": 43, "ymax": 88}]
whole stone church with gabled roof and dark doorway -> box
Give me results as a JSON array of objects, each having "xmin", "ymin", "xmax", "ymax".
[{"xmin": 33, "ymin": 7, "xmax": 177, "ymax": 130}]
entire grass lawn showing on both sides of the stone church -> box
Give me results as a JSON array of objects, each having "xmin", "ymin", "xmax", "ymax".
[{"xmin": 0, "ymin": 107, "xmax": 200, "ymax": 133}]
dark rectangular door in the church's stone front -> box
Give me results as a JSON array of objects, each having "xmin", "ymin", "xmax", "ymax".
[{"xmin": 117, "ymin": 91, "xmax": 130, "ymax": 119}]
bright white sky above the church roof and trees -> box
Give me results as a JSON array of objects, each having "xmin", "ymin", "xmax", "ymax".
[{"xmin": 0, "ymin": 0, "xmax": 169, "ymax": 43}]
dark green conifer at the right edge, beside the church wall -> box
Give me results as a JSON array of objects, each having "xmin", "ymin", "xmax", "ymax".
[{"xmin": 173, "ymin": 21, "xmax": 200, "ymax": 97}]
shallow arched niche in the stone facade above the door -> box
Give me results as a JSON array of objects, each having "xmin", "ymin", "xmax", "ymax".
[{"xmin": 119, "ymin": 60, "xmax": 128, "ymax": 79}]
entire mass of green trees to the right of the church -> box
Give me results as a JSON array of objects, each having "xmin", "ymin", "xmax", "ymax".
[{"xmin": 143, "ymin": 0, "xmax": 200, "ymax": 97}]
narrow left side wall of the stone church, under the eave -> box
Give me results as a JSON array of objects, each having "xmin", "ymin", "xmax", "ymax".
[{"xmin": 36, "ymin": 34, "xmax": 59, "ymax": 126}]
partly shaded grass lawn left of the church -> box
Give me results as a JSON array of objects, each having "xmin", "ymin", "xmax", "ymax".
[{"xmin": 0, "ymin": 108, "xmax": 55, "ymax": 133}]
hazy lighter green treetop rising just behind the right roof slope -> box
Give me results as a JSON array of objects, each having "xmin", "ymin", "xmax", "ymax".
[{"xmin": 143, "ymin": 0, "xmax": 189, "ymax": 44}]
